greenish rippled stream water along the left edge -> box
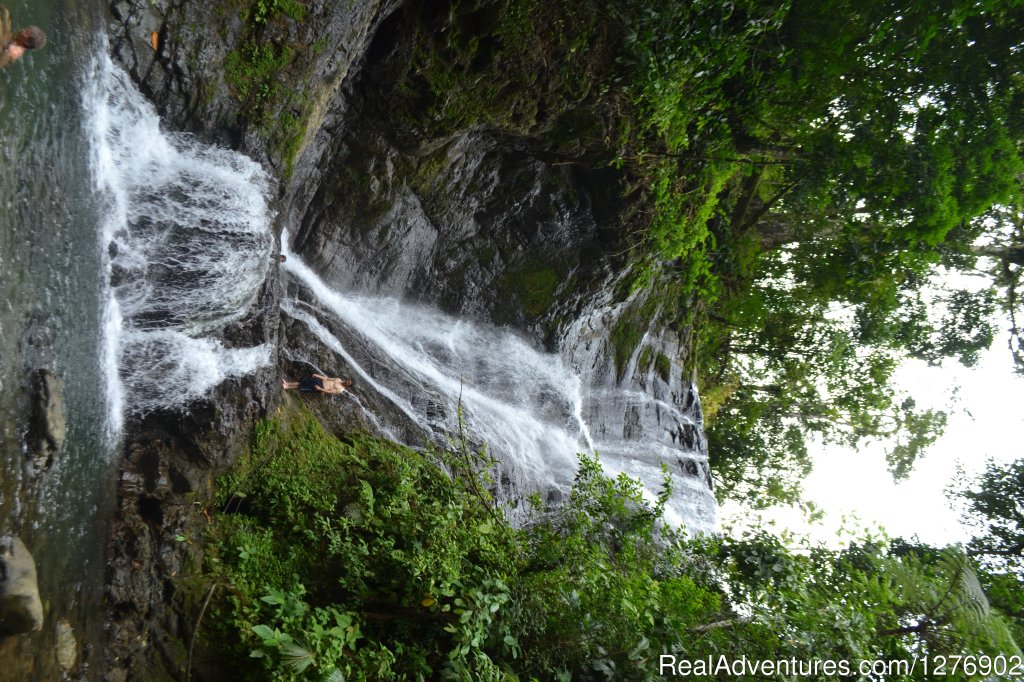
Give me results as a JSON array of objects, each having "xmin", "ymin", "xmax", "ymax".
[{"xmin": 0, "ymin": 0, "xmax": 116, "ymax": 680}]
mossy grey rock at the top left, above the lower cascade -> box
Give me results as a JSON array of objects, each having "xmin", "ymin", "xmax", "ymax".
[{"xmin": 110, "ymin": 0, "xmax": 400, "ymax": 208}]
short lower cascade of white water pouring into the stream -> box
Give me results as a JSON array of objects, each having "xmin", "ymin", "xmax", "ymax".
[{"xmin": 82, "ymin": 50, "xmax": 273, "ymax": 431}]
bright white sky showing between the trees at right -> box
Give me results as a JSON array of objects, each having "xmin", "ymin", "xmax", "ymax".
[{"xmin": 721, "ymin": 335, "xmax": 1024, "ymax": 545}]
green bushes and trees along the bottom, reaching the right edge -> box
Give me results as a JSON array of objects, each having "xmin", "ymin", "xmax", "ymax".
[{"xmin": 195, "ymin": 405, "xmax": 1020, "ymax": 680}]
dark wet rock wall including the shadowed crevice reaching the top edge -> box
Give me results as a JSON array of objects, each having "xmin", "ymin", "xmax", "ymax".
[{"xmin": 290, "ymin": 5, "xmax": 625, "ymax": 337}]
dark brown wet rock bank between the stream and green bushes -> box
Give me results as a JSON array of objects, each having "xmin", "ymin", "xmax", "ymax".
[{"xmin": 99, "ymin": 276, "xmax": 280, "ymax": 682}]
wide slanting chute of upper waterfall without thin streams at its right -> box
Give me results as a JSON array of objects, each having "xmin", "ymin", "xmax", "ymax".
[{"xmin": 282, "ymin": 235, "xmax": 589, "ymax": 489}]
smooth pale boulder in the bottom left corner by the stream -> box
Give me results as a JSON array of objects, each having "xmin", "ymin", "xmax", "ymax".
[{"xmin": 0, "ymin": 536, "xmax": 43, "ymax": 635}]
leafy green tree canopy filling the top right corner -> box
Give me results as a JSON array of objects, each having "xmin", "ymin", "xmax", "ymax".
[{"xmin": 602, "ymin": 0, "xmax": 1024, "ymax": 504}]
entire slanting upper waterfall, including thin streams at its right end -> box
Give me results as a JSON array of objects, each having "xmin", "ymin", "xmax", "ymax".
[{"xmin": 282, "ymin": 232, "xmax": 715, "ymax": 531}]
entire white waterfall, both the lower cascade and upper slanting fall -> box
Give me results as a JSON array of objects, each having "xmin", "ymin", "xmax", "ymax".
[{"xmin": 82, "ymin": 50, "xmax": 715, "ymax": 530}]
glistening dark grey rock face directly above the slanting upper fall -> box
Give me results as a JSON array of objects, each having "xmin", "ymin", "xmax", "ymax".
[{"xmin": 295, "ymin": 123, "xmax": 616, "ymax": 336}]
